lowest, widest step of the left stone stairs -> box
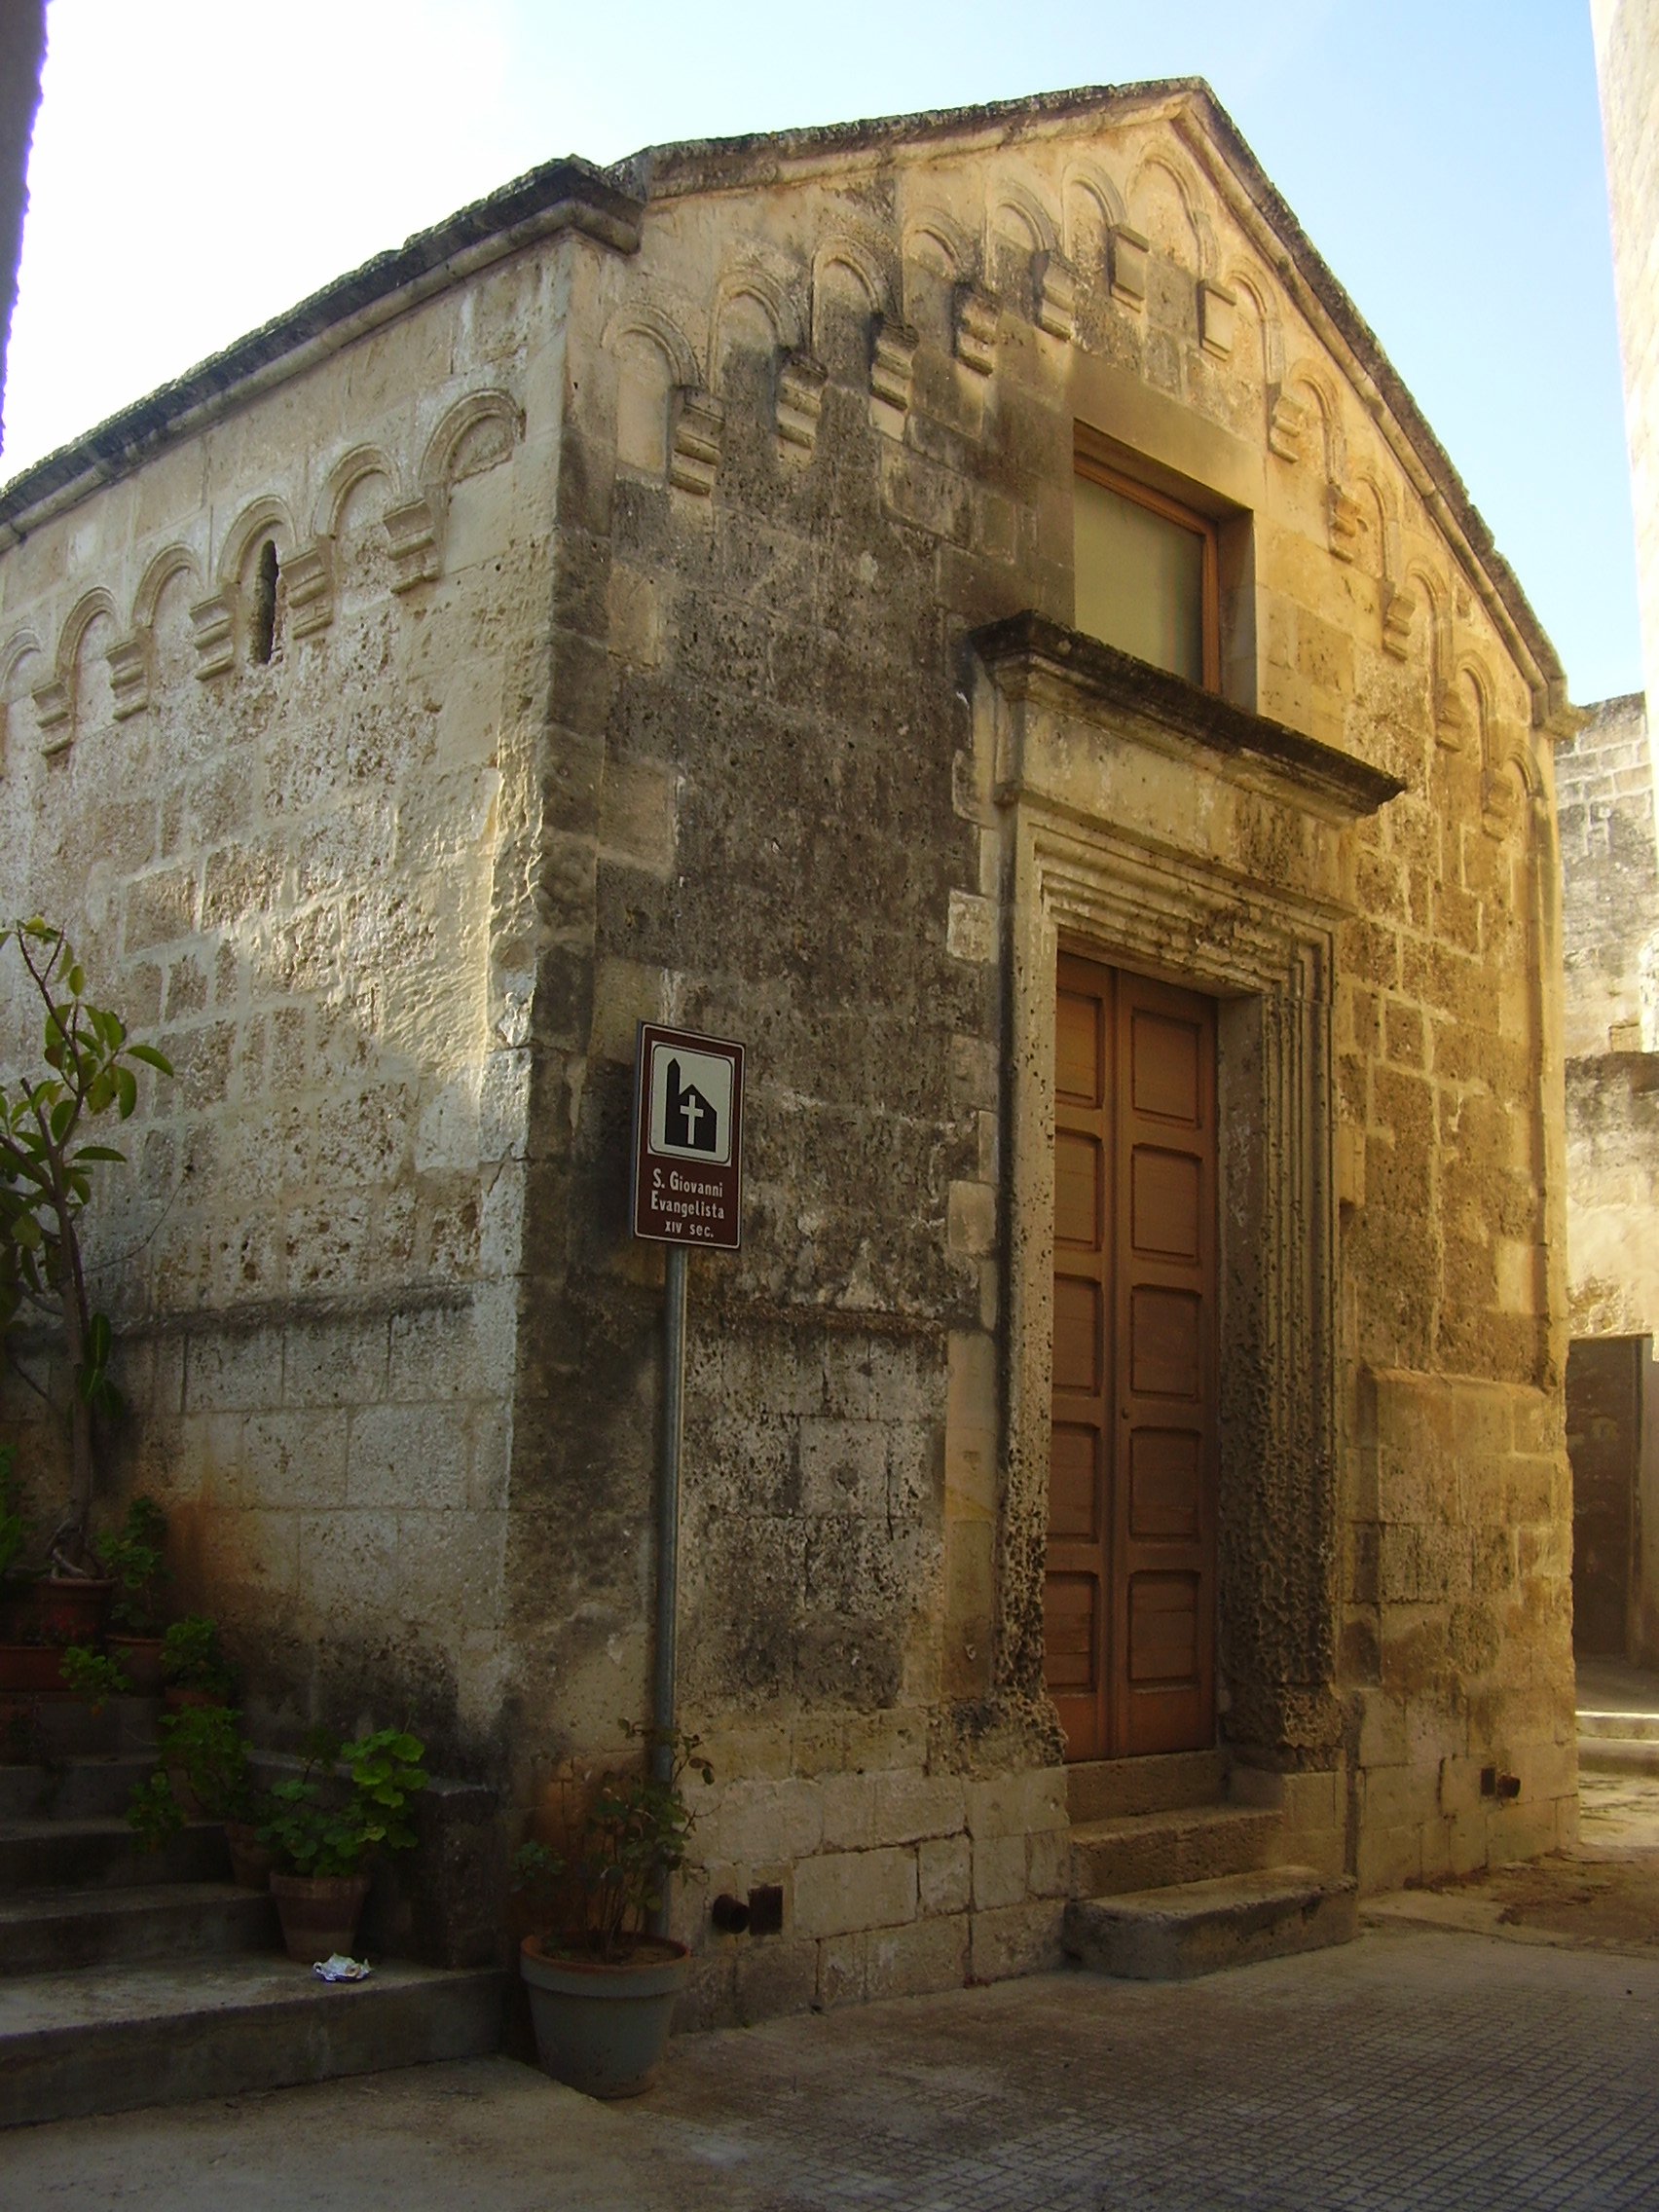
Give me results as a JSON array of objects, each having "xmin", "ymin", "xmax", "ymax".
[{"xmin": 0, "ymin": 1958, "xmax": 506, "ymax": 2128}]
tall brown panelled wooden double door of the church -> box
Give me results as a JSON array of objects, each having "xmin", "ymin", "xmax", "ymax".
[{"xmin": 1044, "ymin": 953, "xmax": 1217, "ymax": 1758}]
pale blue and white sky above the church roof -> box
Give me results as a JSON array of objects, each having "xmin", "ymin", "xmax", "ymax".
[{"xmin": 0, "ymin": 0, "xmax": 1641, "ymax": 699}]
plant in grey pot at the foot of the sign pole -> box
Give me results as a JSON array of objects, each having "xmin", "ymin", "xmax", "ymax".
[{"xmin": 513, "ymin": 1721, "xmax": 715, "ymax": 2097}]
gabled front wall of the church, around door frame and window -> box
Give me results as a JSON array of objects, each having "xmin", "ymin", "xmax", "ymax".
[{"xmin": 529, "ymin": 82, "xmax": 1575, "ymax": 2009}]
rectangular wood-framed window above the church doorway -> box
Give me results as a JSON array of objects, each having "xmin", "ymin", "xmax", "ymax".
[{"xmin": 1073, "ymin": 451, "xmax": 1221, "ymax": 690}]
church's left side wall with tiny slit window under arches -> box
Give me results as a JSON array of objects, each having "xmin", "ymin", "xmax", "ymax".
[{"xmin": 0, "ymin": 268, "xmax": 558, "ymax": 1770}]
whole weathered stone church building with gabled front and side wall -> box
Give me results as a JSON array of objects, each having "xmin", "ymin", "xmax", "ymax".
[{"xmin": 0, "ymin": 82, "xmax": 1577, "ymax": 2019}]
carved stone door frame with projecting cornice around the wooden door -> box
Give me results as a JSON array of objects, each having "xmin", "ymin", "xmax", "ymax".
[{"xmin": 974, "ymin": 615, "xmax": 1402, "ymax": 1765}]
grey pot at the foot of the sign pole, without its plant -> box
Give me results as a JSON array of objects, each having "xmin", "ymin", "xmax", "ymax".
[{"xmin": 518, "ymin": 1936, "xmax": 690, "ymax": 2097}]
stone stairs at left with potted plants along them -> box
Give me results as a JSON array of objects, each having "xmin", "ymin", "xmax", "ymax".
[{"xmin": 0, "ymin": 1699, "xmax": 504, "ymax": 2125}]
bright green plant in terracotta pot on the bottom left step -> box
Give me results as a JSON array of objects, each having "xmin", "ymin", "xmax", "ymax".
[{"xmin": 259, "ymin": 1727, "xmax": 426, "ymax": 1965}]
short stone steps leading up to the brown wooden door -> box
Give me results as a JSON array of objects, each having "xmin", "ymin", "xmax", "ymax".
[{"xmin": 1064, "ymin": 1751, "xmax": 1358, "ymax": 1982}]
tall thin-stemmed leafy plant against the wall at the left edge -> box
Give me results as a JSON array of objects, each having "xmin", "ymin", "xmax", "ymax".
[{"xmin": 0, "ymin": 913, "xmax": 172, "ymax": 1570}]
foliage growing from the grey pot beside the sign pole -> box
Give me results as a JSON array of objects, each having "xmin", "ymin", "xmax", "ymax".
[{"xmin": 513, "ymin": 1721, "xmax": 715, "ymax": 1960}]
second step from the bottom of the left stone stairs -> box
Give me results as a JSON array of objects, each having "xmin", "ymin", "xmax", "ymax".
[{"xmin": 0, "ymin": 1882, "xmax": 281, "ymax": 1975}]
